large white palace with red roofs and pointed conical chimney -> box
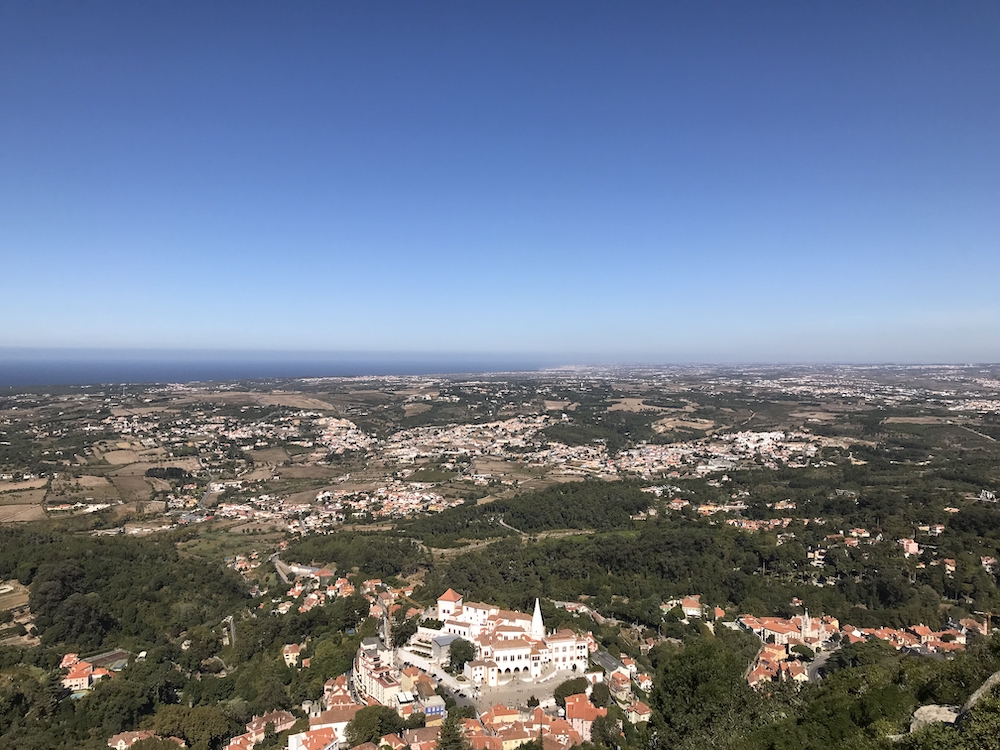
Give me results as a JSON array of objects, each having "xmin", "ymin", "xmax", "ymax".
[{"xmin": 437, "ymin": 589, "xmax": 589, "ymax": 687}]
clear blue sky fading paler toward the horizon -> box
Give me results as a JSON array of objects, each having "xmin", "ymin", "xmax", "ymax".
[{"xmin": 0, "ymin": 0, "xmax": 1000, "ymax": 362}]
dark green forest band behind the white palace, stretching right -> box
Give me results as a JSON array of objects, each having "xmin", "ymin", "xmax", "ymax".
[{"xmin": 414, "ymin": 520, "xmax": 995, "ymax": 627}]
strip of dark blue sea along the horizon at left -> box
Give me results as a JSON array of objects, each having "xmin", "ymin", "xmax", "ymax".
[{"xmin": 0, "ymin": 348, "xmax": 565, "ymax": 388}]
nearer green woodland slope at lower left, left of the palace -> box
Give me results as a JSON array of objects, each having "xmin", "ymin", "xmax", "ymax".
[{"xmin": 0, "ymin": 588, "xmax": 376, "ymax": 750}]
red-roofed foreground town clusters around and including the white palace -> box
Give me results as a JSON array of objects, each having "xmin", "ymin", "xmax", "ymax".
[{"xmin": 60, "ymin": 559, "xmax": 989, "ymax": 750}]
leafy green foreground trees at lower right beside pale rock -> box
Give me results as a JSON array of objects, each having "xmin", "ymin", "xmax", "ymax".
[{"xmin": 646, "ymin": 630, "xmax": 1000, "ymax": 750}]
